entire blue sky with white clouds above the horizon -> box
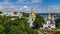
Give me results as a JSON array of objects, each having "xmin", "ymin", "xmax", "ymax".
[{"xmin": 0, "ymin": 0, "xmax": 60, "ymax": 13}]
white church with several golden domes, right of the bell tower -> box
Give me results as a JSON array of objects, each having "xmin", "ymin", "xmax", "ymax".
[{"xmin": 43, "ymin": 13, "xmax": 55, "ymax": 28}]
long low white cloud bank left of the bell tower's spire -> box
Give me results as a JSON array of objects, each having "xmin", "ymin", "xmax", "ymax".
[{"xmin": 0, "ymin": 5, "xmax": 31, "ymax": 13}]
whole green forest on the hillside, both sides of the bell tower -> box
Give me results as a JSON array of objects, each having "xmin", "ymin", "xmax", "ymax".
[{"xmin": 0, "ymin": 14, "xmax": 60, "ymax": 34}]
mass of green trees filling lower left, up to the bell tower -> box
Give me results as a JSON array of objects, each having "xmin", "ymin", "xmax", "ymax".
[{"xmin": 0, "ymin": 16, "xmax": 37, "ymax": 34}]
